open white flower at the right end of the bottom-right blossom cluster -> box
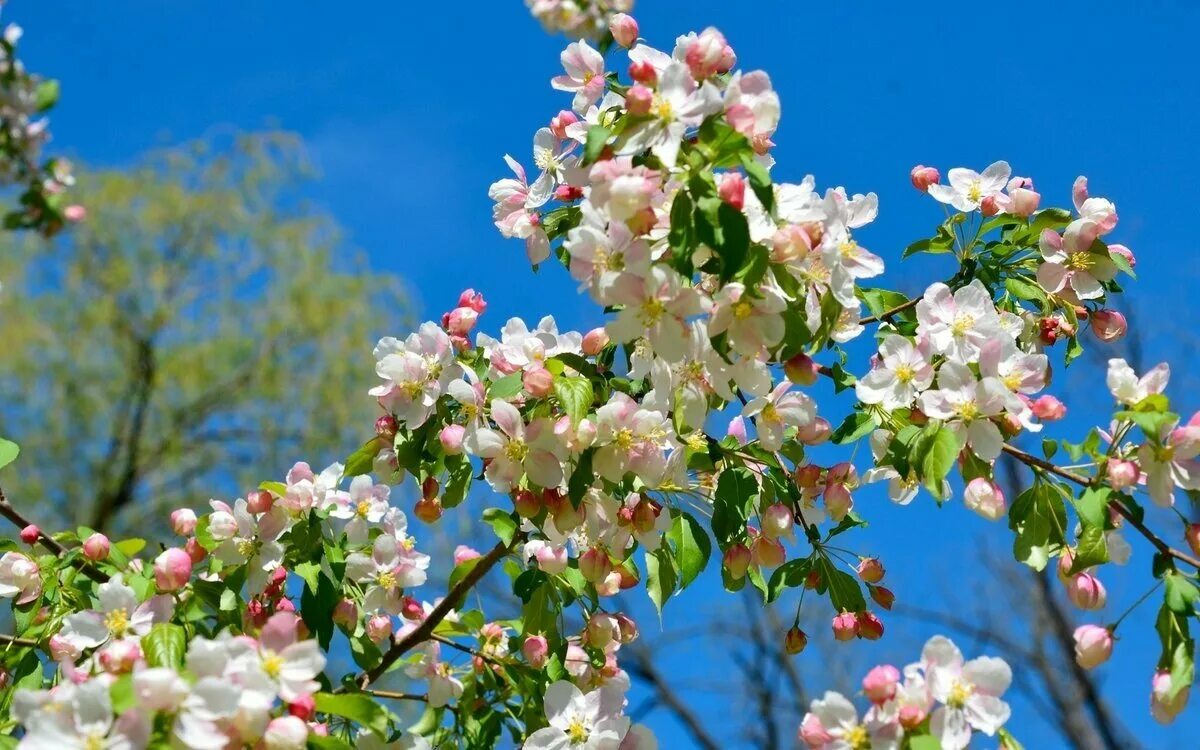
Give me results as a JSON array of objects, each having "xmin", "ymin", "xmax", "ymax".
[{"xmin": 920, "ymin": 636, "xmax": 1013, "ymax": 750}]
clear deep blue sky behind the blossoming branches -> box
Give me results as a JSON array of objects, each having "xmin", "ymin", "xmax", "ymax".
[{"xmin": 14, "ymin": 0, "xmax": 1200, "ymax": 748}]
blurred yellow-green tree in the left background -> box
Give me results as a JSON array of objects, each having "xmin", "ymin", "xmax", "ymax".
[{"xmin": 0, "ymin": 132, "xmax": 407, "ymax": 535}]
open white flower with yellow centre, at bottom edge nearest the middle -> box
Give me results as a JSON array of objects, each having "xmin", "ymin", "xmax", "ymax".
[{"xmin": 524, "ymin": 680, "xmax": 629, "ymax": 750}]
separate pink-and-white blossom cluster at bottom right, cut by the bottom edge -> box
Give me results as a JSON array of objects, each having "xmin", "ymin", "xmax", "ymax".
[{"xmin": 799, "ymin": 636, "xmax": 1018, "ymax": 750}]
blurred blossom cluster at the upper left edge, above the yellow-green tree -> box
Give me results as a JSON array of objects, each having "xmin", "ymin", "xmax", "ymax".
[{"xmin": 0, "ymin": 4, "xmax": 85, "ymax": 235}]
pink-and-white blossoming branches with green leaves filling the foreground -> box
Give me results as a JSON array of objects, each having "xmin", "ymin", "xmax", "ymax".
[{"xmin": 0, "ymin": 7, "xmax": 1200, "ymax": 750}]
